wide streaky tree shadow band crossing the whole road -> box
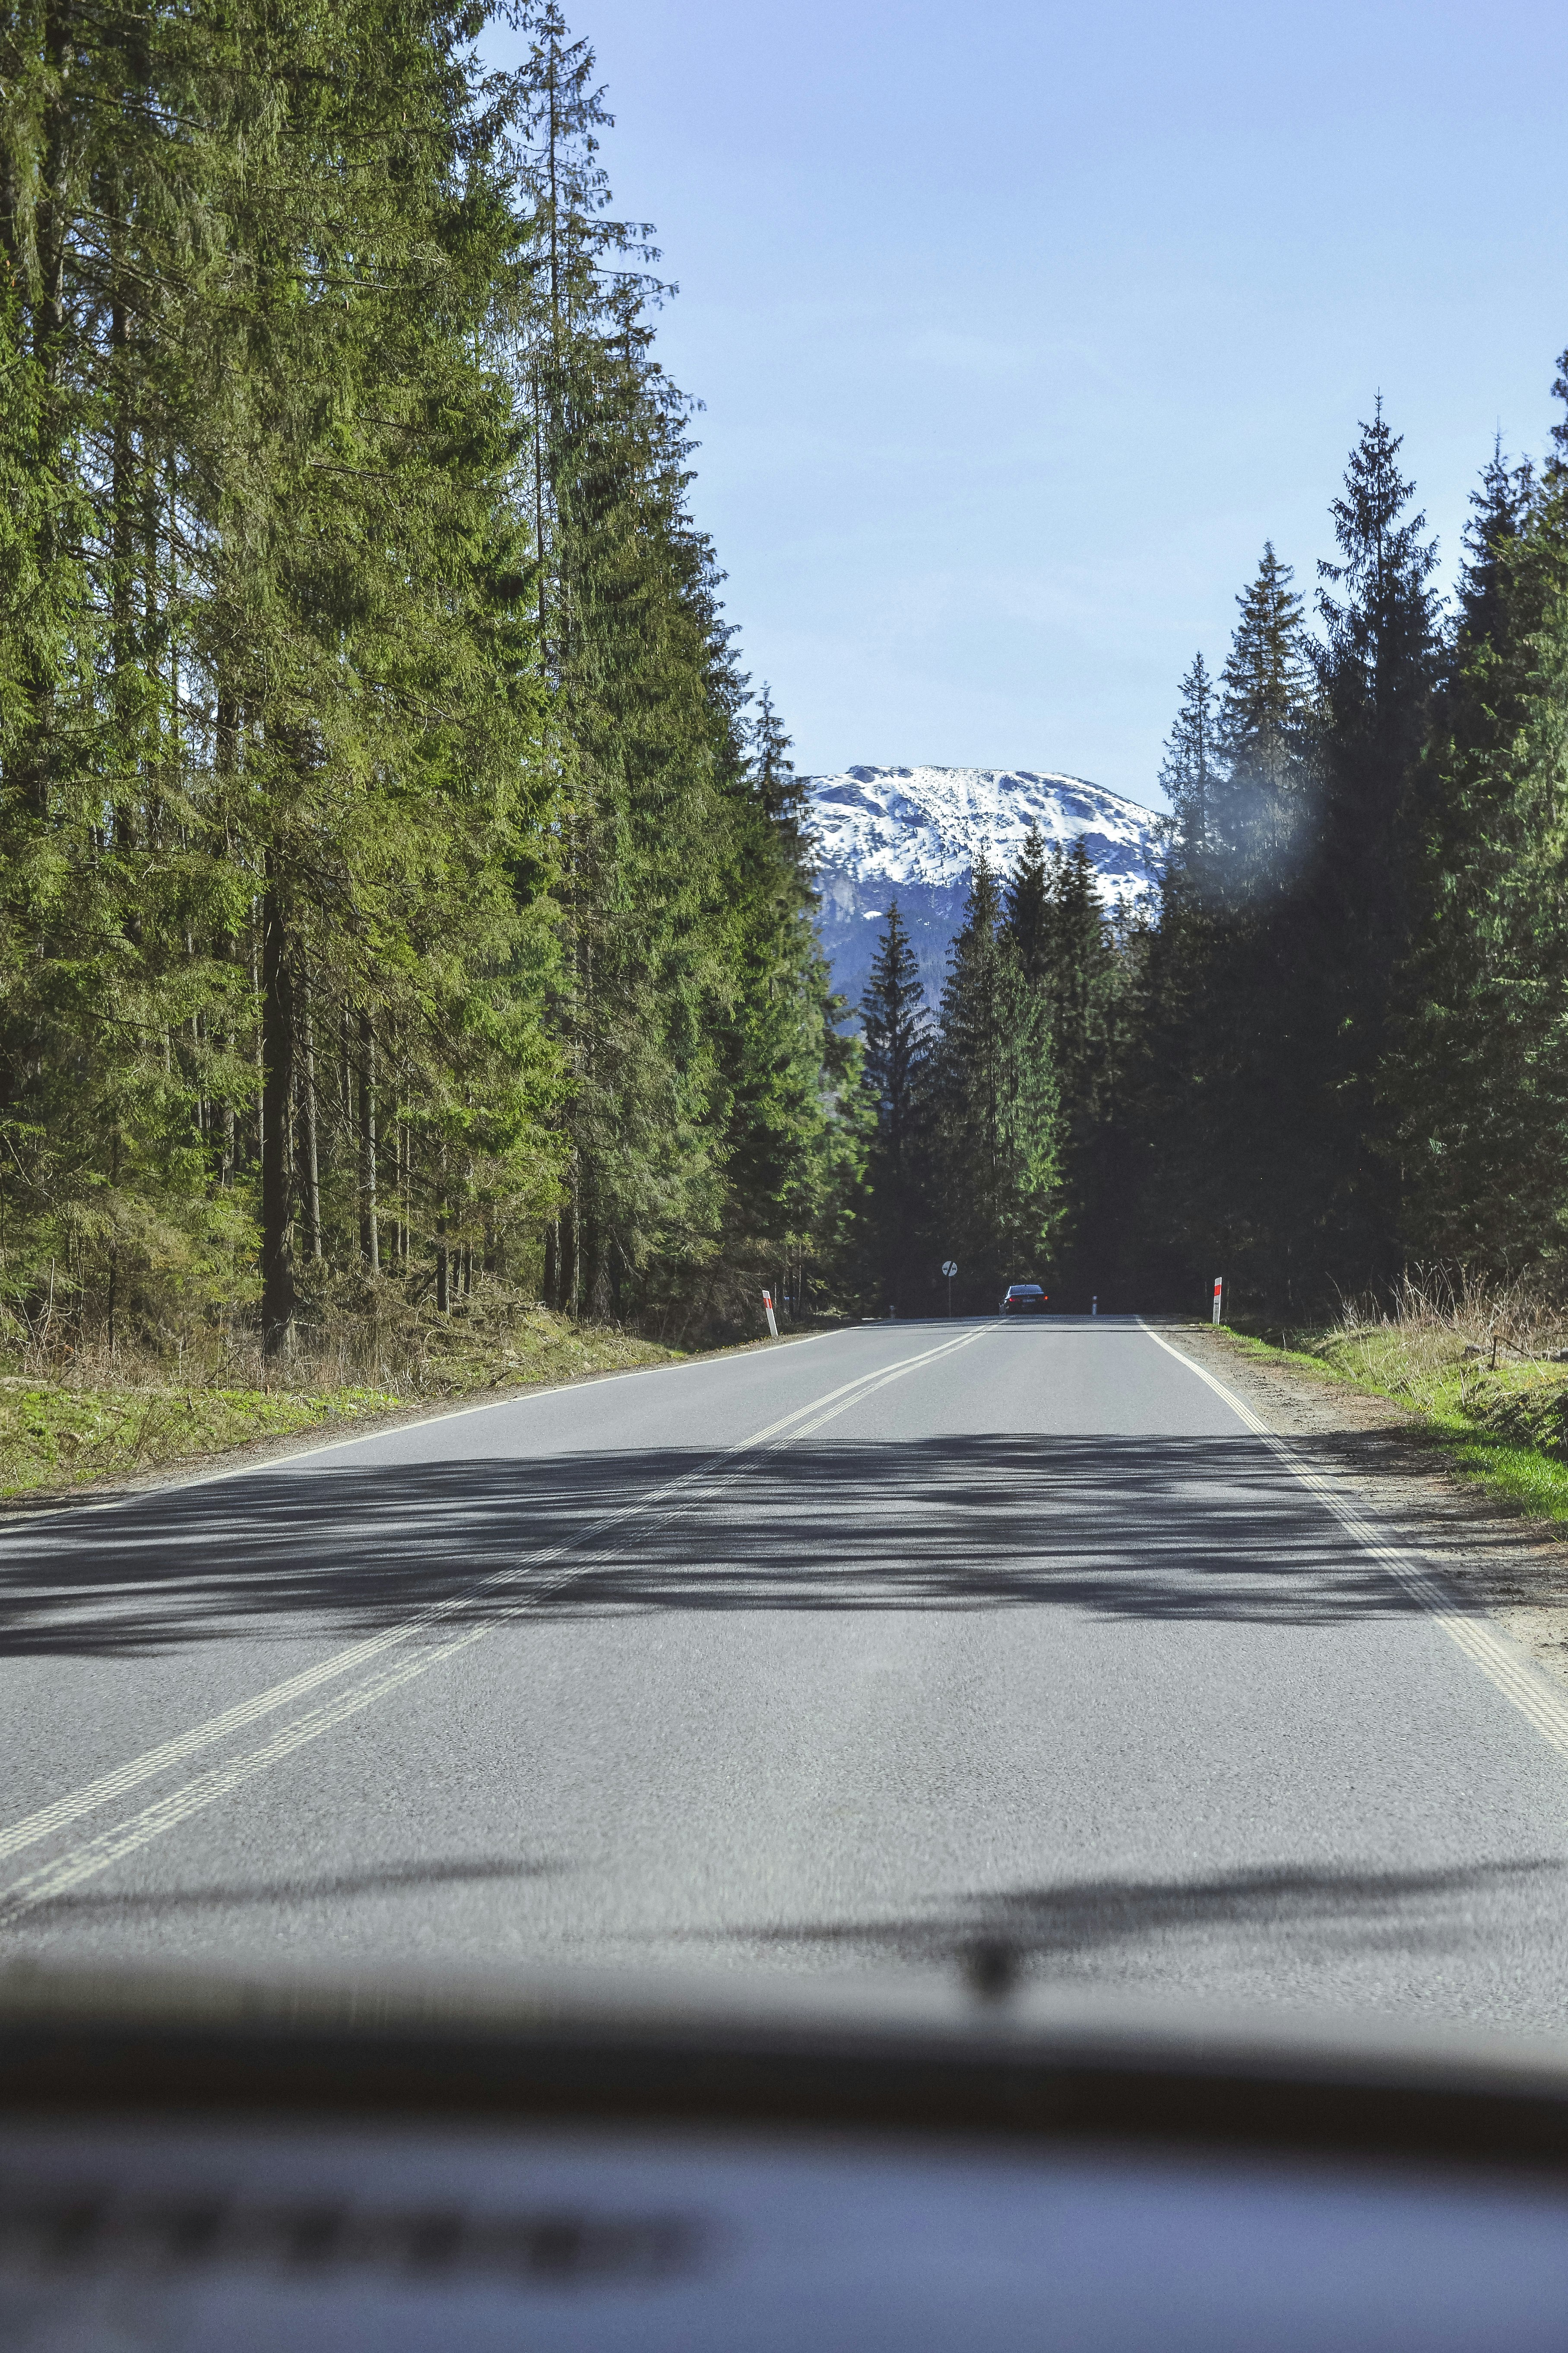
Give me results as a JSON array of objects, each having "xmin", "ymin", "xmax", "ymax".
[{"xmin": 0, "ymin": 1433, "xmax": 1535, "ymax": 1656}]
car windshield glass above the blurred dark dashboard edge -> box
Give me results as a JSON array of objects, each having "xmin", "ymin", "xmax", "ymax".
[{"xmin": 0, "ymin": 0, "xmax": 1568, "ymax": 2071}]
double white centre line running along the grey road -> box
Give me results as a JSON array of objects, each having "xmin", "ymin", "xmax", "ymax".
[{"xmin": 0, "ymin": 1325, "xmax": 989, "ymax": 1892}]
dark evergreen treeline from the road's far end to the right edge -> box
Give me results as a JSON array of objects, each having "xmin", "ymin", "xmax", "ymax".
[{"xmin": 859, "ymin": 376, "xmax": 1568, "ymax": 1318}]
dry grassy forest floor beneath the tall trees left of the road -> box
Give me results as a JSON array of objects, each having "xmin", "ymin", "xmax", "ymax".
[{"xmin": 0, "ymin": 1308, "xmax": 687, "ymax": 1508}]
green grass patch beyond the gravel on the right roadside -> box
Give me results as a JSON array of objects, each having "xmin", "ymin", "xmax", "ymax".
[{"xmin": 1231, "ymin": 1318, "xmax": 1568, "ymax": 1520}]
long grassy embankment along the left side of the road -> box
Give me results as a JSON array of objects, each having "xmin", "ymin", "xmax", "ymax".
[{"xmin": 0, "ymin": 1299, "xmax": 681, "ymax": 1497}]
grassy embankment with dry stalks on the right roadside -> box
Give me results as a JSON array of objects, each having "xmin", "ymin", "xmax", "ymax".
[{"xmin": 1231, "ymin": 1285, "xmax": 1568, "ymax": 1520}]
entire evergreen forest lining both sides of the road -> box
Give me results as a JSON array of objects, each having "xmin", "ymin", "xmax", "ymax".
[{"xmin": 0, "ymin": 0, "xmax": 1568, "ymax": 1367}]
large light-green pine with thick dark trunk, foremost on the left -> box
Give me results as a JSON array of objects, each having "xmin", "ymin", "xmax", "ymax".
[{"xmin": 5, "ymin": 7, "xmax": 563, "ymax": 1353}]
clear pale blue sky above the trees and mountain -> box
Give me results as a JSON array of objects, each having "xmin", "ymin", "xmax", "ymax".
[{"xmin": 490, "ymin": 0, "xmax": 1568, "ymax": 802}]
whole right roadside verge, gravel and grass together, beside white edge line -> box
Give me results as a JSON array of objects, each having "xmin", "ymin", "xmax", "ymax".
[{"xmin": 1170, "ymin": 1325, "xmax": 1568, "ymax": 1682}]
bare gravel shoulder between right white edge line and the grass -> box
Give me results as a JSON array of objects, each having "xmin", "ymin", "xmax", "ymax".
[{"xmin": 1161, "ymin": 1325, "xmax": 1568, "ymax": 1685}]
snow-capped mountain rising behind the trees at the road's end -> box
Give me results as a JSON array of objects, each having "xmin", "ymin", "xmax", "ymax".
[{"xmin": 805, "ymin": 767, "xmax": 1158, "ymax": 1005}]
